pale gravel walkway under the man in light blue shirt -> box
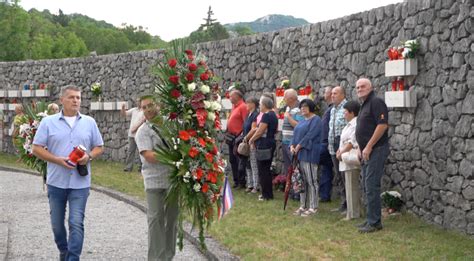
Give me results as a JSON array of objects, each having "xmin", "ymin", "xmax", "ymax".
[{"xmin": 0, "ymin": 171, "xmax": 205, "ymax": 261}]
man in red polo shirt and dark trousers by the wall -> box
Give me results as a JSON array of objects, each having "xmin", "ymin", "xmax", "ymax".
[{"xmin": 226, "ymin": 88, "xmax": 248, "ymax": 188}]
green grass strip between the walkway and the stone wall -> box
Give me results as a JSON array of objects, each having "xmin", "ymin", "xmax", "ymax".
[{"xmin": 0, "ymin": 153, "xmax": 474, "ymax": 260}]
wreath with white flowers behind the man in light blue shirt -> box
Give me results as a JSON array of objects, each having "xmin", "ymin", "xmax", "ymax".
[{"xmin": 13, "ymin": 102, "xmax": 48, "ymax": 183}]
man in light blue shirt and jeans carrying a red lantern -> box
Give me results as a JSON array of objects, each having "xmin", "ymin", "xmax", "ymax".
[{"xmin": 33, "ymin": 86, "xmax": 104, "ymax": 260}]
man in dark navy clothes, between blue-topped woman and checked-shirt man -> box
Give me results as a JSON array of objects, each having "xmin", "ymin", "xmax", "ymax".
[{"xmin": 319, "ymin": 87, "xmax": 333, "ymax": 202}]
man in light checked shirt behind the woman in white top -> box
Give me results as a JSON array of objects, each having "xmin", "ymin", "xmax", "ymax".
[{"xmin": 328, "ymin": 86, "xmax": 347, "ymax": 214}]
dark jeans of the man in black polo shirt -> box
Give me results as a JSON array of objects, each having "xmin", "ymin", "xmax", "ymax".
[{"xmin": 362, "ymin": 143, "xmax": 390, "ymax": 225}]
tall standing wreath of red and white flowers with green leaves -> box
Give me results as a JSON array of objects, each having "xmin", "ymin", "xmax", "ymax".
[{"xmin": 153, "ymin": 42, "xmax": 225, "ymax": 249}]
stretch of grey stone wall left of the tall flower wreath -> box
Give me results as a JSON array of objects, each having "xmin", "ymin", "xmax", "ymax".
[{"xmin": 0, "ymin": 50, "xmax": 162, "ymax": 161}]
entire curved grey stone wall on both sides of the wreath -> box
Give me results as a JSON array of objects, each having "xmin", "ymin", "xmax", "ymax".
[{"xmin": 0, "ymin": 0, "xmax": 474, "ymax": 234}]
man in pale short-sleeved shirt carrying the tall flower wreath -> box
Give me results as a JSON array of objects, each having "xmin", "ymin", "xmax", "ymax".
[{"xmin": 135, "ymin": 96, "xmax": 178, "ymax": 260}]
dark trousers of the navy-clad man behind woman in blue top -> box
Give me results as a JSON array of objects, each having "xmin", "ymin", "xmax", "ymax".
[{"xmin": 319, "ymin": 144, "xmax": 333, "ymax": 200}]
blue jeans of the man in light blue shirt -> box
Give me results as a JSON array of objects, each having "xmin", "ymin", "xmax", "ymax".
[{"xmin": 48, "ymin": 185, "xmax": 89, "ymax": 261}]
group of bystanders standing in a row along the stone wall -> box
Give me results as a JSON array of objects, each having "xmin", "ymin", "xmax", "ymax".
[{"xmin": 225, "ymin": 78, "xmax": 389, "ymax": 233}]
